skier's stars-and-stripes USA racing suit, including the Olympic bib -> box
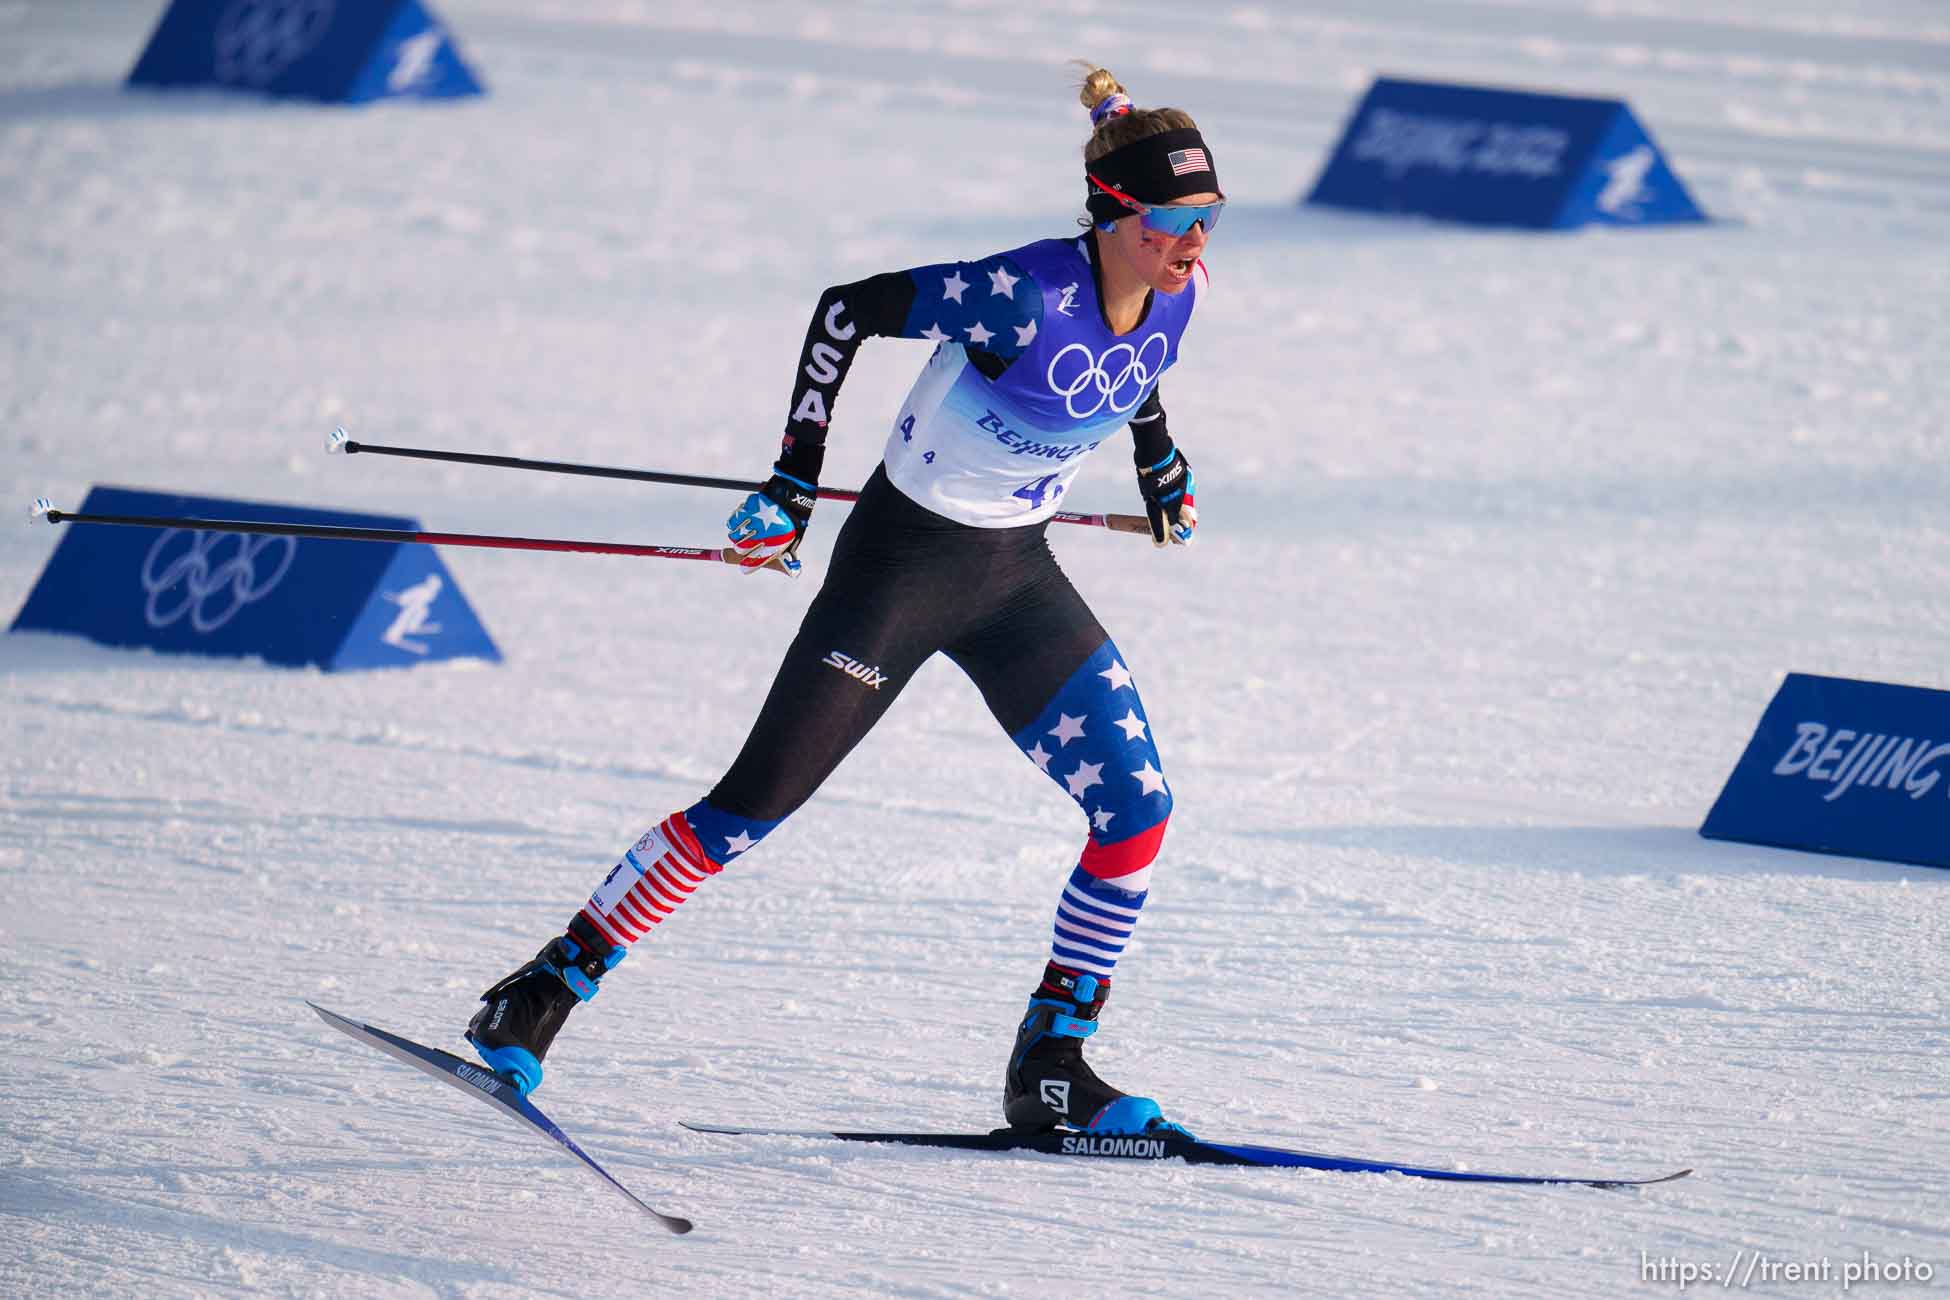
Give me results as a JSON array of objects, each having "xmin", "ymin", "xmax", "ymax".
[{"xmin": 581, "ymin": 232, "xmax": 1205, "ymax": 980}]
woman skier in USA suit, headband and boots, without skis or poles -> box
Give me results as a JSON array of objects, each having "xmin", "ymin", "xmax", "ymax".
[{"xmin": 466, "ymin": 68, "xmax": 1225, "ymax": 1132}]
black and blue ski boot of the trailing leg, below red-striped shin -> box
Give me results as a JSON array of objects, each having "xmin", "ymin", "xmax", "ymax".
[{"xmin": 466, "ymin": 916, "xmax": 630, "ymax": 1097}]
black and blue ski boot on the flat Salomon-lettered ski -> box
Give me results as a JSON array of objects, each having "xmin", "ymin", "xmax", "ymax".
[{"xmin": 1002, "ymin": 963, "xmax": 1191, "ymax": 1136}]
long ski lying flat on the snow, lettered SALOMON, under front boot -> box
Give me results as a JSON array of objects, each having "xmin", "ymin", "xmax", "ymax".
[{"xmin": 683, "ymin": 1121, "xmax": 1693, "ymax": 1187}]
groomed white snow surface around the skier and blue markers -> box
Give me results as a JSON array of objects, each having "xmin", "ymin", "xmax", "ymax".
[{"xmin": 0, "ymin": 0, "xmax": 1950, "ymax": 1296}]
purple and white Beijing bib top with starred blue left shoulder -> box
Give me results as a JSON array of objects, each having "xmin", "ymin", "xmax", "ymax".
[{"xmin": 883, "ymin": 236, "xmax": 1203, "ymax": 528}]
